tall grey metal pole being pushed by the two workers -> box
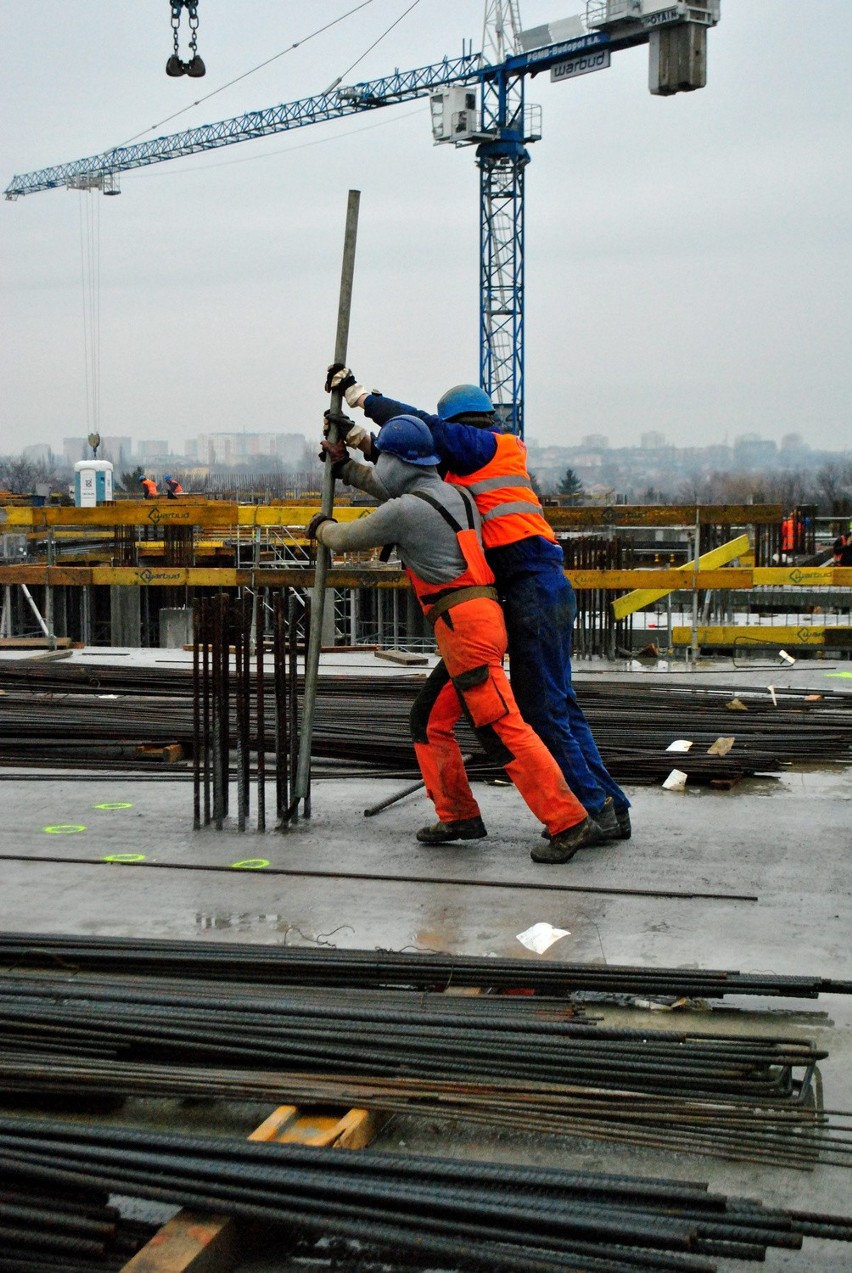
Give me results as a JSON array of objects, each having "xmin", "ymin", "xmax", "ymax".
[{"xmin": 293, "ymin": 190, "xmax": 360, "ymax": 817}]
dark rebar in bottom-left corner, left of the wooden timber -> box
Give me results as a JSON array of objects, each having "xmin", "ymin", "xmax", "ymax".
[{"xmin": 0, "ymin": 1164, "xmax": 157, "ymax": 1273}]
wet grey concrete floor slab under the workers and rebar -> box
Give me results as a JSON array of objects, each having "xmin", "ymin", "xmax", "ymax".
[{"xmin": 0, "ymin": 666, "xmax": 852, "ymax": 1273}]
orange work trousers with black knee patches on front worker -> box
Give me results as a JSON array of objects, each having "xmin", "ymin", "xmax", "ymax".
[{"xmin": 411, "ymin": 597, "xmax": 586, "ymax": 835}]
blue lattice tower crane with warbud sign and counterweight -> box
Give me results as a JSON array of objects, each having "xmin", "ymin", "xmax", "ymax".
[{"xmin": 4, "ymin": 0, "xmax": 721, "ymax": 435}]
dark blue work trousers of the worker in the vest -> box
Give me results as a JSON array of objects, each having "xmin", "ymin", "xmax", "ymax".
[{"xmin": 498, "ymin": 563, "xmax": 630, "ymax": 816}]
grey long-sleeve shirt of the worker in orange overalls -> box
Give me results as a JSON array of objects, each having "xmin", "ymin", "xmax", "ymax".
[{"xmin": 317, "ymin": 453, "xmax": 480, "ymax": 583}]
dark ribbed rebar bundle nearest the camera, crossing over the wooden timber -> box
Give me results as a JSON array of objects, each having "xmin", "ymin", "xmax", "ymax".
[{"xmin": 0, "ymin": 1118, "xmax": 852, "ymax": 1273}]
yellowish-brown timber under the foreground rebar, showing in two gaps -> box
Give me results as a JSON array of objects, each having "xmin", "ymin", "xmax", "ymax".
[{"xmin": 121, "ymin": 1105, "xmax": 383, "ymax": 1273}]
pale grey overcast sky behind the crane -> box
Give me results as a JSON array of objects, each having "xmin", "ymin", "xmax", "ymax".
[{"xmin": 0, "ymin": 0, "xmax": 852, "ymax": 453}]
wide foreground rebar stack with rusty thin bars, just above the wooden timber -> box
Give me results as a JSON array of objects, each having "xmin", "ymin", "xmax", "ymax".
[{"xmin": 0, "ymin": 952, "xmax": 852, "ymax": 1167}]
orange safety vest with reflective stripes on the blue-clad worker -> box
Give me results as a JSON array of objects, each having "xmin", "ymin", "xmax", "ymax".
[{"xmin": 444, "ymin": 433, "xmax": 557, "ymax": 549}]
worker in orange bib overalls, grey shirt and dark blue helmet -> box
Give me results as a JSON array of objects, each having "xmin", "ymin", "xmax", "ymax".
[{"xmin": 307, "ymin": 415, "xmax": 601, "ymax": 862}]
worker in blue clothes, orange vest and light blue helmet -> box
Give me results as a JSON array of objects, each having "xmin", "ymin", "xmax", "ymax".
[{"xmin": 326, "ymin": 363, "xmax": 630, "ymax": 862}]
